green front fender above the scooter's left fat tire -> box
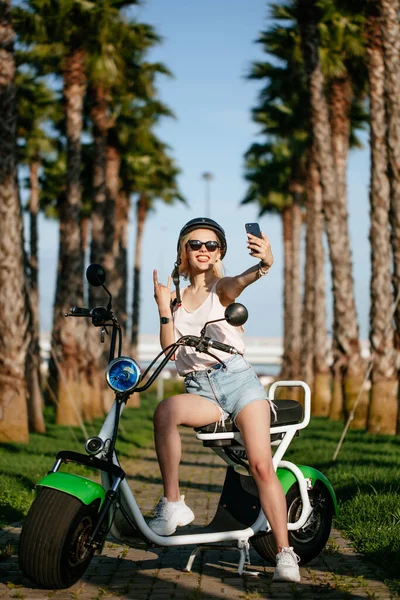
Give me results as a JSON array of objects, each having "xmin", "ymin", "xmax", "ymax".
[{"xmin": 36, "ymin": 471, "xmax": 106, "ymax": 508}]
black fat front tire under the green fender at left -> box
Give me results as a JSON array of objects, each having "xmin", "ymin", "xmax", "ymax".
[{"xmin": 19, "ymin": 488, "xmax": 98, "ymax": 589}]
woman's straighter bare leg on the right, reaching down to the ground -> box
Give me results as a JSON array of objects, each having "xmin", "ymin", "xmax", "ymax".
[{"xmin": 236, "ymin": 400, "xmax": 289, "ymax": 551}]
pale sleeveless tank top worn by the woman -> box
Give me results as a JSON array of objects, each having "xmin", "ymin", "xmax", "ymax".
[{"xmin": 173, "ymin": 281, "xmax": 245, "ymax": 375}]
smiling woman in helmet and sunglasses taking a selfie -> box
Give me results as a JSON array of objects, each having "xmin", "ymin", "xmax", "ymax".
[{"xmin": 149, "ymin": 218, "xmax": 300, "ymax": 582}]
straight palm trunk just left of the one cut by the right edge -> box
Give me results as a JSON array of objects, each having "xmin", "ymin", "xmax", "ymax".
[{"xmin": 367, "ymin": 3, "xmax": 398, "ymax": 434}]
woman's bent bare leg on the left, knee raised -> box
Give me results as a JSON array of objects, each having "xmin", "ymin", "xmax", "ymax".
[{"xmin": 153, "ymin": 394, "xmax": 221, "ymax": 502}]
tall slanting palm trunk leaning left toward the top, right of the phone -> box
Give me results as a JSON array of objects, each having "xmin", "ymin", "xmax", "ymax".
[{"xmin": 299, "ymin": 0, "xmax": 368, "ymax": 426}]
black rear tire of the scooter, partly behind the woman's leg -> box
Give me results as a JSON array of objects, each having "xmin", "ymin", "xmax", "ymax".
[{"xmin": 250, "ymin": 482, "xmax": 333, "ymax": 565}]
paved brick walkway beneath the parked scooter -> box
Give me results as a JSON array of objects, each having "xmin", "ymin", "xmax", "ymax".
[{"xmin": 0, "ymin": 430, "xmax": 393, "ymax": 600}]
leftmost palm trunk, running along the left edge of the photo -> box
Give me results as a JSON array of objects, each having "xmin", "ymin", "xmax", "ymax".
[{"xmin": 0, "ymin": 0, "xmax": 29, "ymax": 442}]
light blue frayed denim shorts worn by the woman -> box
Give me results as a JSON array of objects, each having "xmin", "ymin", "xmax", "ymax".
[{"xmin": 184, "ymin": 354, "xmax": 267, "ymax": 421}]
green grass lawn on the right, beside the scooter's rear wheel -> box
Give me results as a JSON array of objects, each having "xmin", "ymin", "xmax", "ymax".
[{"xmin": 285, "ymin": 419, "xmax": 400, "ymax": 593}]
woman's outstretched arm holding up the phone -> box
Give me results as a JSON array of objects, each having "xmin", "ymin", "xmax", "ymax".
[{"xmin": 217, "ymin": 233, "xmax": 274, "ymax": 304}]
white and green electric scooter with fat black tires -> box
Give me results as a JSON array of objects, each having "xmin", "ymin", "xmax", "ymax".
[{"xmin": 19, "ymin": 264, "xmax": 337, "ymax": 589}]
